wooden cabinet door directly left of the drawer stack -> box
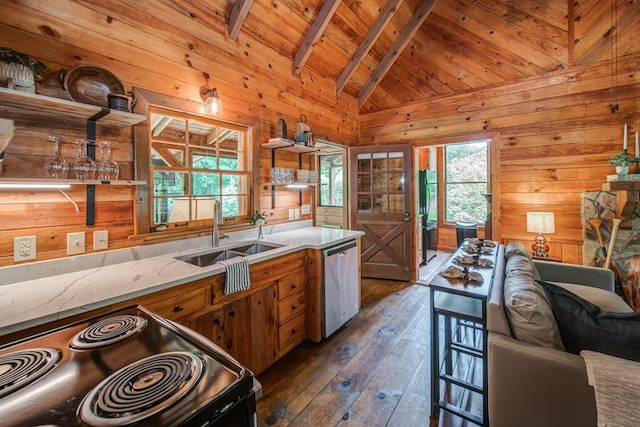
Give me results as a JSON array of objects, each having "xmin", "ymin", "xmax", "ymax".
[{"xmin": 250, "ymin": 285, "xmax": 278, "ymax": 374}]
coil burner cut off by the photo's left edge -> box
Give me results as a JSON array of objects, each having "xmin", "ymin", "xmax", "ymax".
[{"xmin": 0, "ymin": 348, "xmax": 60, "ymax": 398}]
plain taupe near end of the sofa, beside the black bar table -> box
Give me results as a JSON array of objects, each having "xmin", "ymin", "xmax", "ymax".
[{"xmin": 488, "ymin": 332, "xmax": 597, "ymax": 427}]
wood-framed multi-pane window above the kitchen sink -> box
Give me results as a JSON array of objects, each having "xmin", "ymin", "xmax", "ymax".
[{"xmin": 149, "ymin": 108, "xmax": 251, "ymax": 228}]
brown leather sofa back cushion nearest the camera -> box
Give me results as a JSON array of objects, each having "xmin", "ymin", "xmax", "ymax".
[{"xmin": 504, "ymin": 251, "xmax": 564, "ymax": 350}]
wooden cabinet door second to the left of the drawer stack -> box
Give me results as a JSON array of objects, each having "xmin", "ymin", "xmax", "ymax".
[{"xmin": 223, "ymin": 297, "xmax": 251, "ymax": 366}]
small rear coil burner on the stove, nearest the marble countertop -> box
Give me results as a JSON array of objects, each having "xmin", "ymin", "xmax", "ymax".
[{"xmin": 69, "ymin": 315, "xmax": 147, "ymax": 350}]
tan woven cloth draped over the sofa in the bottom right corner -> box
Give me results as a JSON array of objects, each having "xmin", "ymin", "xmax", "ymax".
[{"xmin": 580, "ymin": 350, "xmax": 640, "ymax": 427}]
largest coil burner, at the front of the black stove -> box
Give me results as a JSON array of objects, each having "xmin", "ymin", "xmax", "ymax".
[{"xmin": 79, "ymin": 351, "xmax": 204, "ymax": 427}]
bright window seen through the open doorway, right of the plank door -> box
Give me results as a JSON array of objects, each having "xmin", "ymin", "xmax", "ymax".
[{"xmin": 444, "ymin": 140, "xmax": 489, "ymax": 223}]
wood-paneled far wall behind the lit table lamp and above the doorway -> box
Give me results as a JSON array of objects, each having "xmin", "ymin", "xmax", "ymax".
[{"xmin": 360, "ymin": 55, "xmax": 640, "ymax": 263}]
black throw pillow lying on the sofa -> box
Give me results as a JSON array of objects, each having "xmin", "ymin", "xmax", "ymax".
[{"xmin": 538, "ymin": 280, "xmax": 640, "ymax": 361}]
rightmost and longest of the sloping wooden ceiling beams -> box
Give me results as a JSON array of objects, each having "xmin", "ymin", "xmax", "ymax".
[{"xmin": 358, "ymin": 0, "xmax": 437, "ymax": 108}]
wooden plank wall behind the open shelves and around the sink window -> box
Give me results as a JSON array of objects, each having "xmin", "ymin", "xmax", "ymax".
[{"xmin": 0, "ymin": 0, "xmax": 358, "ymax": 266}]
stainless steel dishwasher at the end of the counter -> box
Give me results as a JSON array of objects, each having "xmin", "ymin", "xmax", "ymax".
[{"xmin": 322, "ymin": 240, "xmax": 360, "ymax": 338}]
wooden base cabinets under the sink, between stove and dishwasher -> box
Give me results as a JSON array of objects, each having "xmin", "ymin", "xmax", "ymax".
[{"xmin": 114, "ymin": 251, "xmax": 307, "ymax": 374}]
